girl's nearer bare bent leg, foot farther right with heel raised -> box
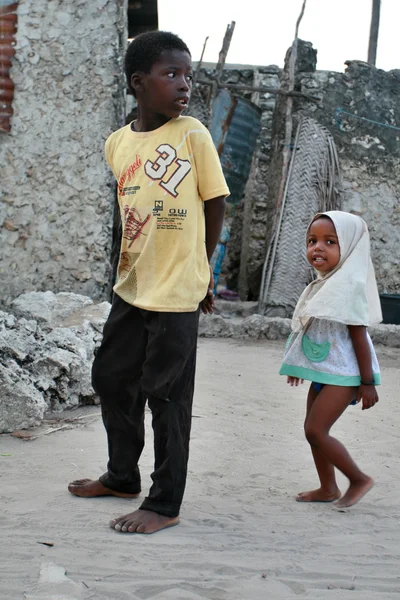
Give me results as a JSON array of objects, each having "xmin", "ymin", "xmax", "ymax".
[{"xmin": 305, "ymin": 385, "xmax": 374, "ymax": 507}]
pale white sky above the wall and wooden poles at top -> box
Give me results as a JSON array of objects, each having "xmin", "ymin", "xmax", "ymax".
[{"xmin": 158, "ymin": 0, "xmax": 400, "ymax": 71}]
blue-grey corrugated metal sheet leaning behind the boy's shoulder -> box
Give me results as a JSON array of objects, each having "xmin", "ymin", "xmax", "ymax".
[{"xmin": 211, "ymin": 90, "xmax": 261, "ymax": 205}]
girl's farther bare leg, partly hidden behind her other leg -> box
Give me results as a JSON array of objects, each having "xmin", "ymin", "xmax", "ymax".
[{"xmin": 296, "ymin": 385, "xmax": 341, "ymax": 502}]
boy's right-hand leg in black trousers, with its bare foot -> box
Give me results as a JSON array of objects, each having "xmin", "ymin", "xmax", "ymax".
[{"xmin": 110, "ymin": 312, "xmax": 199, "ymax": 533}]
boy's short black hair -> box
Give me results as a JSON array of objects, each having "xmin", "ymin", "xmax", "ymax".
[{"xmin": 125, "ymin": 31, "xmax": 191, "ymax": 92}]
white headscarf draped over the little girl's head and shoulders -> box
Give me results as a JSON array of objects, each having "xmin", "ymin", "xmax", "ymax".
[{"xmin": 292, "ymin": 210, "xmax": 382, "ymax": 331}]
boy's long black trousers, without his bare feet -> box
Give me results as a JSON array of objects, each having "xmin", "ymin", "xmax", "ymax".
[{"xmin": 92, "ymin": 294, "xmax": 199, "ymax": 517}]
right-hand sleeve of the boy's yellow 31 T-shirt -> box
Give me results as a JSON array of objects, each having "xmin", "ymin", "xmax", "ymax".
[{"xmin": 191, "ymin": 122, "xmax": 230, "ymax": 202}]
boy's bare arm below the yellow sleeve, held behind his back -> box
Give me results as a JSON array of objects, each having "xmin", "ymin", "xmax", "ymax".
[{"xmin": 200, "ymin": 196, "xmax": 225, "ymax": 315}]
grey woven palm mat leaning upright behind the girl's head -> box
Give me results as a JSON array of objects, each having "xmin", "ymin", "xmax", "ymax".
[{"xmin": 260, "ymin": 117, "xmax": 340, "ymax": 316}]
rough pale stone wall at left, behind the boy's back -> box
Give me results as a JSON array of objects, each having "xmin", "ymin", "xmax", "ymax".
[{"xmin": 0, "ymin": 0, "xmax": 126, "ymax": 302}]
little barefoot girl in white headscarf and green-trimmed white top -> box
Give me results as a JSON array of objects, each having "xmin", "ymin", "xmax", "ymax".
[{"xmin": 280, "ymin": 211, "xmax": 382, "ymax": 508}]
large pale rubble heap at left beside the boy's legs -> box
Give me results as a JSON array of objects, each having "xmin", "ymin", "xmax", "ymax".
[{"xmin": 0, "ymin": 292, "xmax": 110, "ymax": 433}]
